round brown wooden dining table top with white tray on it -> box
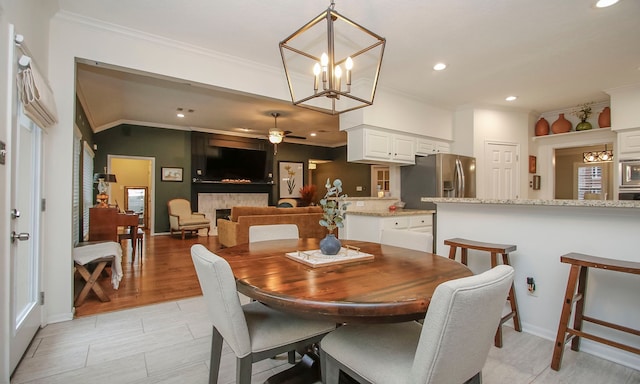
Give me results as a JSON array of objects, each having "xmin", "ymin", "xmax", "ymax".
[{"xmin": 216, "ymin": 239, "xmax": 472, "ymax": 323}]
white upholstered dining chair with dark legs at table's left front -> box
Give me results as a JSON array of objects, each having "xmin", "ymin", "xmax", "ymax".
[{"xmin": 191, "ymin": 244, "xmax": 335, "ymax": 384}]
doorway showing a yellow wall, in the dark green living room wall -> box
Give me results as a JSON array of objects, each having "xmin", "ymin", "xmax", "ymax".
[{"xmin": 107, "ymin": 155, "xmax": 155, "ymax": 233}]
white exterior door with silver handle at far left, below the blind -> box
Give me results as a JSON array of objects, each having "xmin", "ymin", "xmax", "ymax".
[{"xmin": 10, "ymin": 104, "xmax": 42, "ymax": 372}]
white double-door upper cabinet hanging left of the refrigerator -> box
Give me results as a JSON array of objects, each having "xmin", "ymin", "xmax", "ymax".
[{"xmin": 347, "ymin": 127, "xmax": 415, "ymax": 164}]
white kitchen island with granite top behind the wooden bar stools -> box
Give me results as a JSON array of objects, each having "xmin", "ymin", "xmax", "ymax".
[{"xmin": 422, "ymin": 198, "xmax": 640, "ymax": 369}]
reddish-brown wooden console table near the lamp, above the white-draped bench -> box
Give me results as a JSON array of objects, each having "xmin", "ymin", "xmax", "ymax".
[{"xmin": 89, "ymin": 208, "xmax": 139, "ymax": 264}]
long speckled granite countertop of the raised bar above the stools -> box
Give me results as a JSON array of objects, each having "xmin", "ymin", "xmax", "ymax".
[{"xmin": 420, "ymin": 197, "xmax": 640, "ymax": 208}]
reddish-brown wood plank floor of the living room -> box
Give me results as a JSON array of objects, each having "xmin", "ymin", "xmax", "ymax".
[{"xmin": 75, "ymin": 232, "xmax": 220, "ymax": 317}]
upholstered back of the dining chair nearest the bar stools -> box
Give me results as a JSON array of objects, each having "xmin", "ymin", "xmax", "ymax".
[{"xmin": 411, "ymin": 265, "xmax": 514, "ymax": 384}]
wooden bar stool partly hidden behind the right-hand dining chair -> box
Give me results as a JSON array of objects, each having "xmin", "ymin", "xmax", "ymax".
[{"xmin": 444, "ymin": 237, "xmax": 522, "ymax": 348}]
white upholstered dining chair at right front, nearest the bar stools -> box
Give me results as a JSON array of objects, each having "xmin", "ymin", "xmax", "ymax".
[{"xmin": 320, "ymin": 265, "xmax": 514, "ymax": 384}]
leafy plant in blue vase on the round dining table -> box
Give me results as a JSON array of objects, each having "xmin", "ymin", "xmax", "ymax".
[{"xmin": 320, "ymin": 179, "xmax": 349, "ymax": 255}]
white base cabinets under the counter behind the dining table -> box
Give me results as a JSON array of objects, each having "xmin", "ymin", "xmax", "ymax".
[{"xmin": 339, "ymin": 212, "xmax": 433, "ymax": 243}]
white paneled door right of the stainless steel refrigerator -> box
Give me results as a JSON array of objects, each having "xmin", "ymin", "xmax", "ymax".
[{"xmin": 485, "ymin": 143, "xmax": 519, "ymax": 199}]
